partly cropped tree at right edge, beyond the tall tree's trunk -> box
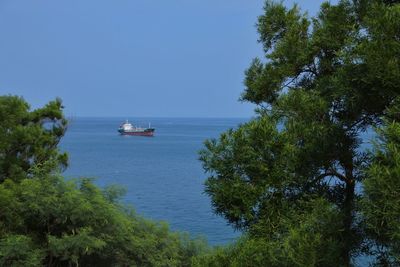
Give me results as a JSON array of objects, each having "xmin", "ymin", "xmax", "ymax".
[{"xmin": 361, "ymin": 111, "xmax": 400, "ymax": 266}]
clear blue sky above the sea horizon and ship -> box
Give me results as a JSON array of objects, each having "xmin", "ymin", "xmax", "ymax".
[{"xmin": 0, "ymin": 0, "xmax": 334, "ymax": 117}]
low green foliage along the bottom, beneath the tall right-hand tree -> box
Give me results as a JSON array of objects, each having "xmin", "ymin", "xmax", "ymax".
[{"xmin": 194, "ymin": 199, "xmax": 343, "ymax": 267}]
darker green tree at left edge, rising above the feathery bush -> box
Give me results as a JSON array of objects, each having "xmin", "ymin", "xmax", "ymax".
[{"xmin": 0, "ymin": 96, "xmax": 68, "ymax": 183}]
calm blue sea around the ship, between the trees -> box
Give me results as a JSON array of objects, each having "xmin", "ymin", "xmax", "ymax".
[{"xmin": 61, "ymin": 118, "xmax": 248, "ymax": 245}]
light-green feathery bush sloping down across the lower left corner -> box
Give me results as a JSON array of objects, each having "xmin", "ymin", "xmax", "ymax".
[{"xmin": 0, "ymin": 172, "xmax": 203, "ymax": 266}]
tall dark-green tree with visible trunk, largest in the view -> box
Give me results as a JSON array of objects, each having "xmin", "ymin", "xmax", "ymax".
[{"xmin": 200, "ymin": 0, "xmax": 400, "ymax": 266}]
